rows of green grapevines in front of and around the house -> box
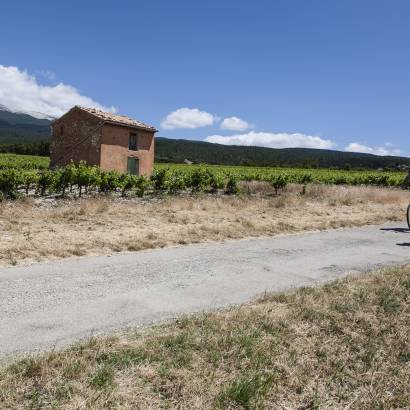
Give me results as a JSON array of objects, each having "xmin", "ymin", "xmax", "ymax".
[{"xmin": 0, "ymin": 154, "xmax": 405, "ymax": 200}]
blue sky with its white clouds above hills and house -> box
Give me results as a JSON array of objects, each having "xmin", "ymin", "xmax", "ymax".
[{"xmin": 0, "ymin": 0, "xmax": 410, "ymax": 155}]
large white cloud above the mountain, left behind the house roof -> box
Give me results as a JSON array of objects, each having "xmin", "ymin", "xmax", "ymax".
[{"xmin": 0, "ymin": 65, "xmax": 116, "ymax": 118}]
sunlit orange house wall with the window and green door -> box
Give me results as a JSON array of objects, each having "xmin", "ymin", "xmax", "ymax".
[{"xmin": 100, "ymin": 124, "xmax": 154, "ymax": 176}]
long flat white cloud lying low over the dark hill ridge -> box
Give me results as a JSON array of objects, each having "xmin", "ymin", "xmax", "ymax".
[{"xmin": 205, "ymin": 131, "xmax": 336, "ymax": 149}]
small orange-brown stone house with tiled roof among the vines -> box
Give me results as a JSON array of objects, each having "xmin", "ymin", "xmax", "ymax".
[{"xmin": 50, "ymin": 106, "xmax": 157, "ymax": 176}]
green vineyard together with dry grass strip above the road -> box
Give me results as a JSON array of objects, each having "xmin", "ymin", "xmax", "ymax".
[{"xmin": 0, "ymin": 154, "xmax": 410, "ymax": 265}]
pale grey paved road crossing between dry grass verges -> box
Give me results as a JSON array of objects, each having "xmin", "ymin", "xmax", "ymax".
[{"xmin": 0, "ymin": 225, "xmax": 410, "ymax": 356}]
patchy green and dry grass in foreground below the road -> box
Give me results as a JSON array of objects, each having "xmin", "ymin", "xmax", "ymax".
[{"xmin": 0, "ymin": 265, "xmax": 410, "ymax": 409}]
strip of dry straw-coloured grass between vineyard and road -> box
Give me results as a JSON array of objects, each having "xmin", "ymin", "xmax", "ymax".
[{"xmin": 0, "ymin": 182, "xmax": 410, "ymax": 265}]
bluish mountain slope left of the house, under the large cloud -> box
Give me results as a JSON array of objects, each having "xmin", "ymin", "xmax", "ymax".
[{"xmin": 0, "ymin": 106, "xmax": 50, "ymax": 144}]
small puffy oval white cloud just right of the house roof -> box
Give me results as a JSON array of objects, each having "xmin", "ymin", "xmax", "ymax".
[{"xmin": 161, "ymin": 108, "xmax": 217, "ymax": 130}]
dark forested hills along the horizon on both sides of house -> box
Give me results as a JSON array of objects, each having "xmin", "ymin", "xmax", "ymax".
[{"xmin": 0, "ymin": 106, "xmax": 410, "ymax": 169}]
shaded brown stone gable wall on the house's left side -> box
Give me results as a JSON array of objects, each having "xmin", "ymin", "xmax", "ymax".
[{"xmin": 50, "ymin": 109, "xmax": 102, "ymax": 168}]
